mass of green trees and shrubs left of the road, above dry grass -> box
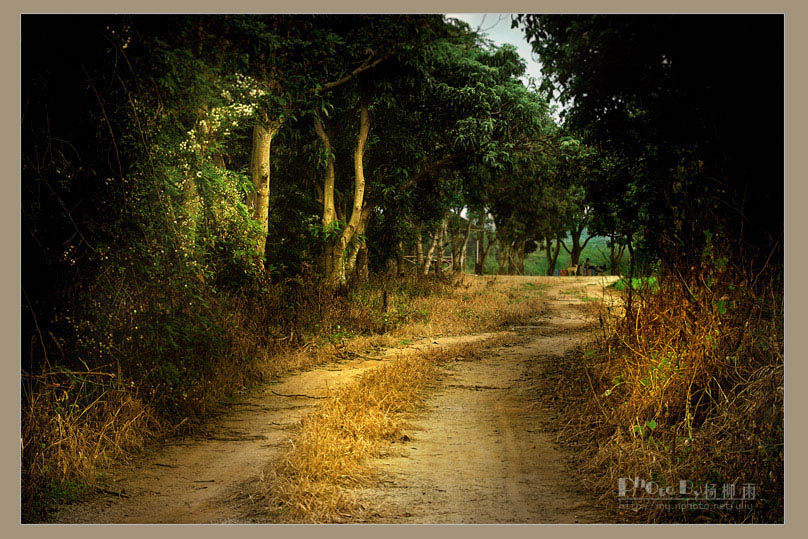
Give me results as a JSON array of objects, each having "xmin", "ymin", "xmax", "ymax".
[{"xmin": 22, "ymin": 16, "xmax": 612, "ymax": 385}]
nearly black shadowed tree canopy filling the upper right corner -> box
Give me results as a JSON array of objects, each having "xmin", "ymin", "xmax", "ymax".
[{"xmin": 514, "ymin": 15, "xmax": 783, "ymax": 264}]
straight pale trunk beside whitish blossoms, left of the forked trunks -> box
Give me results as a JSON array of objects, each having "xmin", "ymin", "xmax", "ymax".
[{"xmin": 249, "ymin": 113, "xmax": 279, "ymax": 266}]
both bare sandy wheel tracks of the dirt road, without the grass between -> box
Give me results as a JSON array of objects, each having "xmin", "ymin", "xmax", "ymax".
[{"xmin": 52, "ymin": 277, "xmax": 620, "ymax": 523}]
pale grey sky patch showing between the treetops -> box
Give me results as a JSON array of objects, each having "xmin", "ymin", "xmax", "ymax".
[{"xmin": 445, "ymin": 13, "xmax": 561, "ymax": 121}]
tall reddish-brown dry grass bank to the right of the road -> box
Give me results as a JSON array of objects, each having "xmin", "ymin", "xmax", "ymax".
[{"xmin": 536, "ymin": 252, "xmax": 783, "ymax": 522}]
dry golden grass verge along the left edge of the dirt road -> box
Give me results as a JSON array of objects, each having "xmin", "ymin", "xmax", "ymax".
[{"xmin": 22, "ymin": 275, "xmax": 541, "ymax": 521}]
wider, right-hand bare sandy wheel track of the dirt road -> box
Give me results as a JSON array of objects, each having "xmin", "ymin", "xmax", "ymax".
[{"xmin": 357, "ymin": 278, "xmax": 613, "ymax": 523}]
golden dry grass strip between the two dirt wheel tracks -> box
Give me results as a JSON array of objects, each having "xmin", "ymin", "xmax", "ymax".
[{"xmin": 249, "ymin": 335, "xmax": 513, "ymax": 523}]
